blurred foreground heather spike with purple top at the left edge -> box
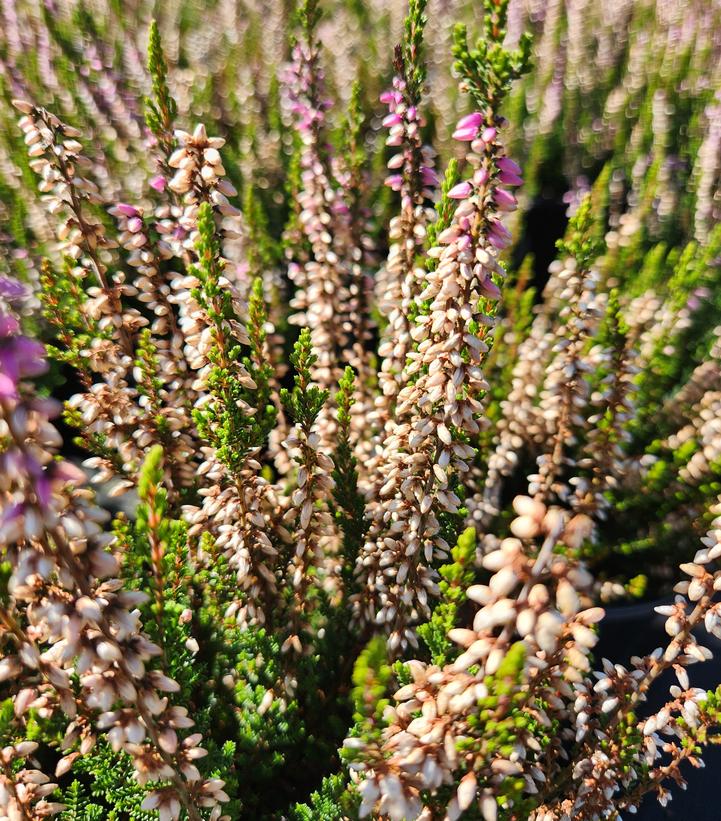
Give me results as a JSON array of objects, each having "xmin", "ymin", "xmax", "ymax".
[{"xmin": 0, "ymin": 278, "xmax": 221, "ymax": 821}]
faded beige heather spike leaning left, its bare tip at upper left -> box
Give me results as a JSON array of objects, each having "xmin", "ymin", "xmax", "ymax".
[{"xmin": 21, "ymin": 106, "xmax": 189, "ymax": 500}]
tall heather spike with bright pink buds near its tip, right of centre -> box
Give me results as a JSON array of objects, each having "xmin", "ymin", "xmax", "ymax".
[{"xmin": 357, "ymin": 9, "xmax": 528, "ymax": 654}]
